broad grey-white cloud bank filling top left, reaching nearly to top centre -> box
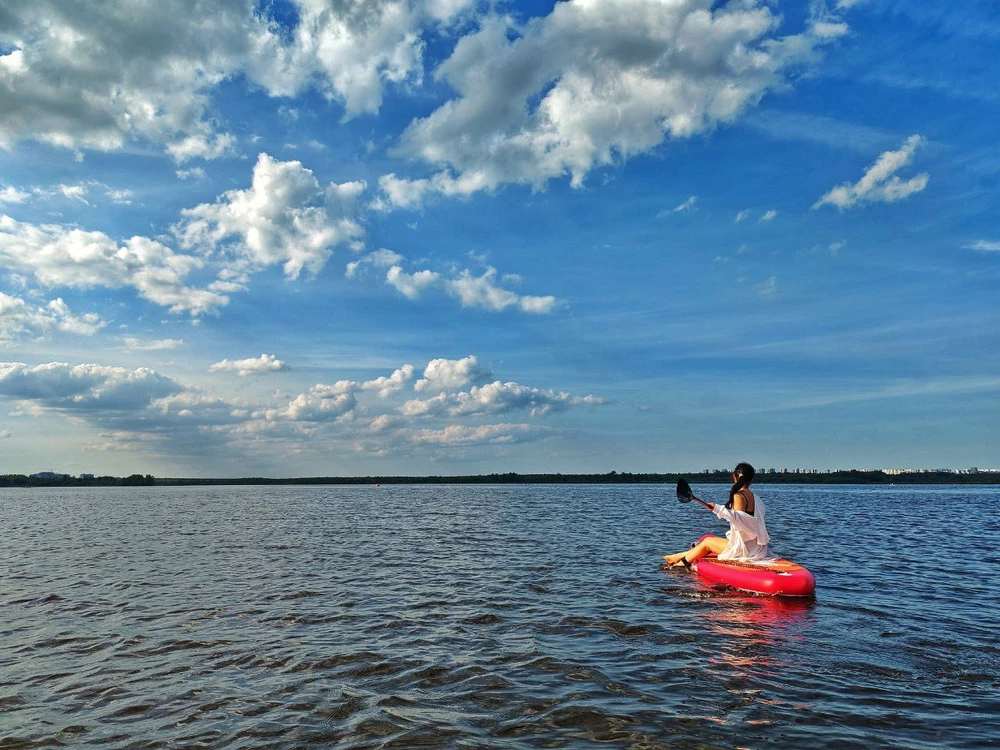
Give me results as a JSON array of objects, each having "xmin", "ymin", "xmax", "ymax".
[{"xmin": 0, "ymin": 0, "xmax": 473, "ymax": 162}]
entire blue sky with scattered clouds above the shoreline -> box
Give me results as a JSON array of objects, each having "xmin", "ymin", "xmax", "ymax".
[{"xmin": 0, "ymin": 0, "xmax": 1000, "ymax": 476}]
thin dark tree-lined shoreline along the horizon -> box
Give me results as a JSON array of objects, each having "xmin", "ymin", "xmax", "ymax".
[{"xmin": 0, "ymin": 470, "xmax": 1000, "ymax": 487}]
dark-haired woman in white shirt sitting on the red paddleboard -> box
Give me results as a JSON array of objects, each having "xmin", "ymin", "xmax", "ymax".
[{"xmin": 663, "ymin": 463, "xmax": 773, "ymax": 568}]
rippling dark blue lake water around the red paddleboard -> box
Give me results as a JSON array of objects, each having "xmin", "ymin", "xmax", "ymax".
[{"xmin": 0, "ymin": 483, "xmax": 1000, "ymax": 750}]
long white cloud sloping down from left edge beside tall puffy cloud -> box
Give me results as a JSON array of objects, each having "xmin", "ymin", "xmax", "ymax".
[{"xmin": 0, "ymin": 214, "xmax": 229, "ymax": 315}]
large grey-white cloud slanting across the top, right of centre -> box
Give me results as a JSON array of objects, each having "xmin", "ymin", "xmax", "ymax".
[{"xmin": 380, "ymin": 0, "xmax": 846, "ymax": 207}]
